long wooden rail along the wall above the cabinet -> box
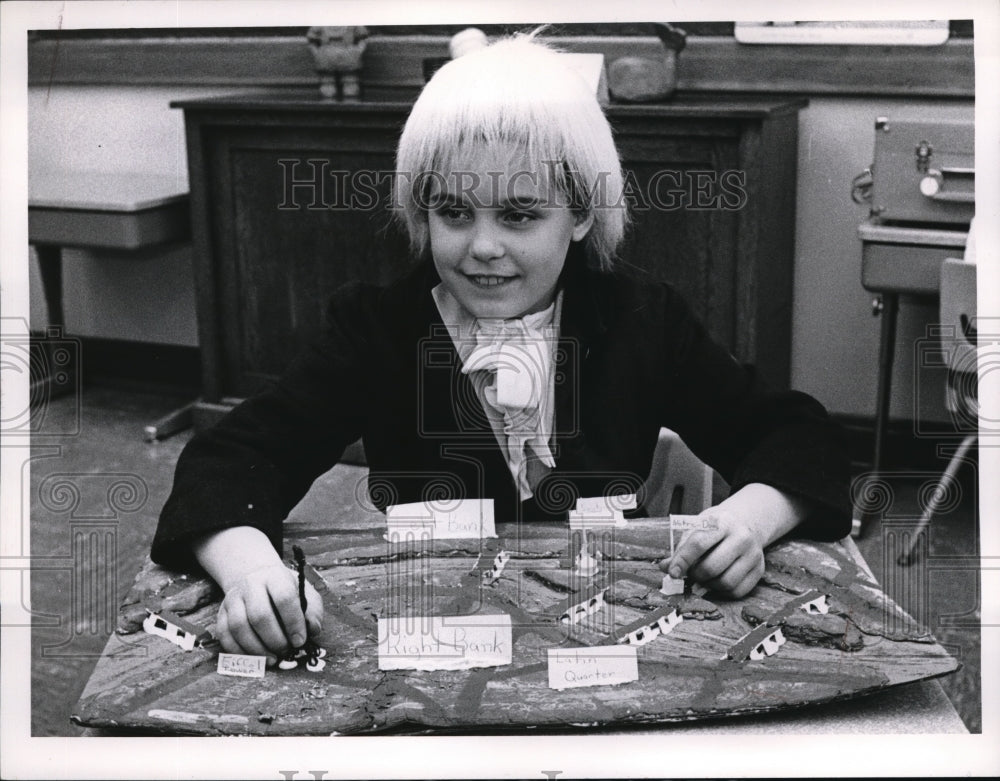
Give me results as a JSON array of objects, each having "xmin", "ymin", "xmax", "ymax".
[{"xmin": 28, "ymin": 34, "xmax": 975, "ymax": 98}]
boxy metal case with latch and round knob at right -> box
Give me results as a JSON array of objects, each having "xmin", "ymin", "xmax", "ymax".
[{"xmin": 871, "ymin": 117, "xmax": 976, "ymax": 226}]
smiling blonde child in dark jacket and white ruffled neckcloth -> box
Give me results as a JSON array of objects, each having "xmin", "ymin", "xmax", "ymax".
[{"xmin": 152, "ymin": 32, "xmax": 850, "ymax": 663}]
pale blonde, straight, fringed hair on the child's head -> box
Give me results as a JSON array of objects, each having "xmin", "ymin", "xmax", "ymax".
[{"xmin": 394, "ymin": 35, "xmax": 627, "ymax": 270}]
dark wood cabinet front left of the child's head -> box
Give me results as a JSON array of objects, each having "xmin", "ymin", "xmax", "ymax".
[{"xmin": 187, "ymin": 103, "xmax": 408, "ymax": 401}]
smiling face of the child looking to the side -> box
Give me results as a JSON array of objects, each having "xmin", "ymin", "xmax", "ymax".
[{"xmin": 427, "ymin": 151, "xmax": 593, "ymax": 319}]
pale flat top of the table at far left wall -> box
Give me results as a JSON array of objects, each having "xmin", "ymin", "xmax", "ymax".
[{"xmin": 28, "ymin": 171, "xmax": 188, "ymax": 212}]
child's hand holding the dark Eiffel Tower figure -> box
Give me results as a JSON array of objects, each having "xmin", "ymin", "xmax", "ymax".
[{"xmin": 215, "ymin": 564, "xmax": 323, "ymax": 665}]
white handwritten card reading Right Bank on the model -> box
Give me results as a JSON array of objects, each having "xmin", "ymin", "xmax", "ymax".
[{"xmin": 378, "ymin": 613, "xmax": 514, "ymax": 670}]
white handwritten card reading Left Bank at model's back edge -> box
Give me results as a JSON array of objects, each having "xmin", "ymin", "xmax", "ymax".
[{"xmin": 385, "ymin": 499, "xmax": 497, "ymax": 542}]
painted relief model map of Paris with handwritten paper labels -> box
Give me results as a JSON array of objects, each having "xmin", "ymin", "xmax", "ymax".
[{"xmin": 74, "ymin": 500, "xmax": 958, "ymax": 735}]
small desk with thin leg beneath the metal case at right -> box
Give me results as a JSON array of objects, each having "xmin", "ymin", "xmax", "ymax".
[{"xmin": 858, "ymin": 219, "xmax": 968, "ymax": 472}]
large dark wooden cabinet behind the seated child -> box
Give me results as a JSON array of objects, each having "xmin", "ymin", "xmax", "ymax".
[{"xmin": 173, "ymin": 91, "xmax": 805, "ymax": 420}]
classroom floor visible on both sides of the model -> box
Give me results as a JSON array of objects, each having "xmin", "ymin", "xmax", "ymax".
[{"xmin": 30, "ymin": 387, "xmax": 982, "ymax": 736}]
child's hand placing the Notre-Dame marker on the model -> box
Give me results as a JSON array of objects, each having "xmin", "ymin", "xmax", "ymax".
[{"xmin": 660, "ymin": 483, "xmax": 806, "ymax": 599}]
